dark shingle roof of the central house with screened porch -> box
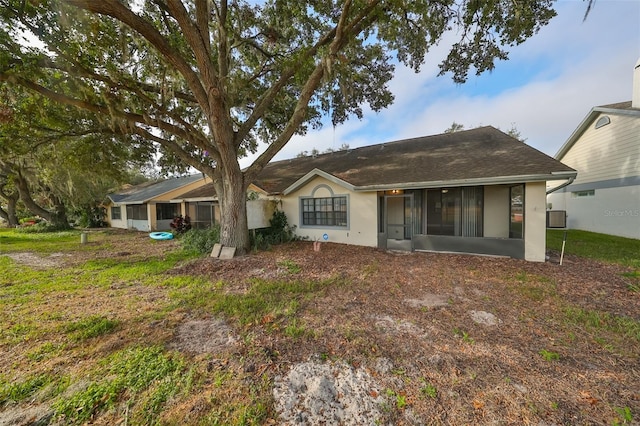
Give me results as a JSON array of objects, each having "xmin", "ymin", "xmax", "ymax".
[{"xmin": 254, "ymin": 127, "xmax": 574, "ymax": 194}]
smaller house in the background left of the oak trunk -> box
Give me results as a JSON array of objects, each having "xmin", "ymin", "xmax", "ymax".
[{"xmin": 107, "ymin": 174, "xmax": 211, "ymax": 231}]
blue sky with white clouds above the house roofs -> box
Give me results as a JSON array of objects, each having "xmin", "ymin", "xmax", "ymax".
[{"xmin": 240, "ymin": 0, "xmax": 640, "ymax": 167}]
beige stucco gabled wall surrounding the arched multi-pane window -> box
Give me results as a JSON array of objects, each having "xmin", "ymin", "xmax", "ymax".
[{"xmin": 281, "ymin": 177, "xmax": 378, "ymax": 247}]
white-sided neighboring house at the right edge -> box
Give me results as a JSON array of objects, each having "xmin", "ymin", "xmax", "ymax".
[{"xmin": 547, "ymin": 60, "xmax": 640, "ymax": 239}]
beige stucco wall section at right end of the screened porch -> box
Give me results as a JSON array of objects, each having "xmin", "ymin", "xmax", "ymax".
[{"xmin": 524, "ymin": 182, "xmax": 547, "ymax": 262}]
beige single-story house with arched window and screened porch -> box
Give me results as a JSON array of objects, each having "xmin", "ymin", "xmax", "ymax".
[{"xmin": 253, "ymin": 126, "xmax": 576, "ymax": 261}]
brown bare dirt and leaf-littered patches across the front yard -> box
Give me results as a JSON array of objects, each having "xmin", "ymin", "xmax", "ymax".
[{"xmin": 0, "ymin": 236, "xmax": 640, "ymax": 425}]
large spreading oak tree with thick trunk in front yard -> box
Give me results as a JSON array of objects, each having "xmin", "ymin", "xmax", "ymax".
[{"xmin": 0, "ymin": 0, "xmax": 555, "ymax": 252}]
